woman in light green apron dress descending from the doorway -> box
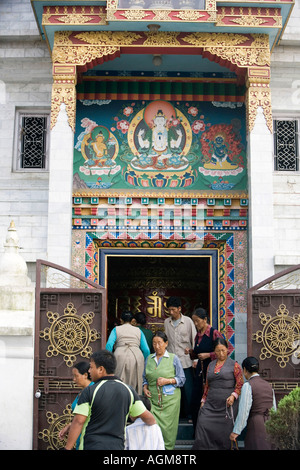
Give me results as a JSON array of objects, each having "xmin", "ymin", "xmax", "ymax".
[{"xmin": 143, "ymin": 331, "xmax": 185, "ymax": 450}]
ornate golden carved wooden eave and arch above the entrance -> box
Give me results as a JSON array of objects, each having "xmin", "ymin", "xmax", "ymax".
[{"xmin": 31, "ymin": 0, "xmax": 295, "ymax": 131}]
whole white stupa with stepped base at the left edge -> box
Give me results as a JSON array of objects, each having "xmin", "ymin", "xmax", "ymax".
[{"xmin": 0, "ymin": 222, "xmax": 35, "ymax": 450}]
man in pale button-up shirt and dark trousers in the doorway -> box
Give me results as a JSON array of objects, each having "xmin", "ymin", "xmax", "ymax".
[{"xmin": 164, "ymin": 297, "xmax": 197, "ymax": 419}]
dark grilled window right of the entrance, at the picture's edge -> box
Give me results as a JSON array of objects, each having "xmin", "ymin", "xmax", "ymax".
[{"xmin": 274, "ymin": 119, "xmax": 299, "ymax": 171}]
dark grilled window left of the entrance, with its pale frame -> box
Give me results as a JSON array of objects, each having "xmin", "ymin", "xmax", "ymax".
[{"xmin": 15, "ymin": 112, "xmax": 49, "ymax": 171}]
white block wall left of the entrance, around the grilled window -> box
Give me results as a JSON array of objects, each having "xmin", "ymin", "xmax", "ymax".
[{"xmin": 0, "ymin": 0, "xmax": 52, "ymax": 277}]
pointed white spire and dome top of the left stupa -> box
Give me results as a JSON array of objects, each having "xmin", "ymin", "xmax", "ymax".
[{"xmin": 0, "ymin": 221, "xmax": 31, "ymax": 288}]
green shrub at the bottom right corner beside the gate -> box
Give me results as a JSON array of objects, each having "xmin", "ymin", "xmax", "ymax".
[{"xmin": 266, "ymin": 387, "xmax": 300, "ymax": 450}]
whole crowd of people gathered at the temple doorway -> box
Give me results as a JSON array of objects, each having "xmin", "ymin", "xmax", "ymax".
[{"xmin": 59, "ymin": 297, "xmax": 276, "ymax": 450}]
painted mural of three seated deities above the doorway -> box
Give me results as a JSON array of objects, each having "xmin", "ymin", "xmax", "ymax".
[{"xmin": 74, "ymin": 100, "xmax": 247, "ymax": 194}]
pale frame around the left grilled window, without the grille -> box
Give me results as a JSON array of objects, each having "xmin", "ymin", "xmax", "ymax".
[{"xmin": 12, "ymin": 107, "xmax": 50, "ymax": 173}]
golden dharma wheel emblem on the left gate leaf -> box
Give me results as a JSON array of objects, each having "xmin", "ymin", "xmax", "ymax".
[{"xmin": 40, "ymin": 303, "xmax": 100, "ymax": 367}]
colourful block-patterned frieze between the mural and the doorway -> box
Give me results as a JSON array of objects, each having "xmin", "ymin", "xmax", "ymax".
[{"xmin": 73, "ymin": 197, "xmax": 248, "ymax": 232}]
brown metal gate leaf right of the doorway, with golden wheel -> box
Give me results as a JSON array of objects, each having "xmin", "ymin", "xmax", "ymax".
[{"xmin": 247, "ymin": 265, "xmax": 300, "ymax": 401}]
